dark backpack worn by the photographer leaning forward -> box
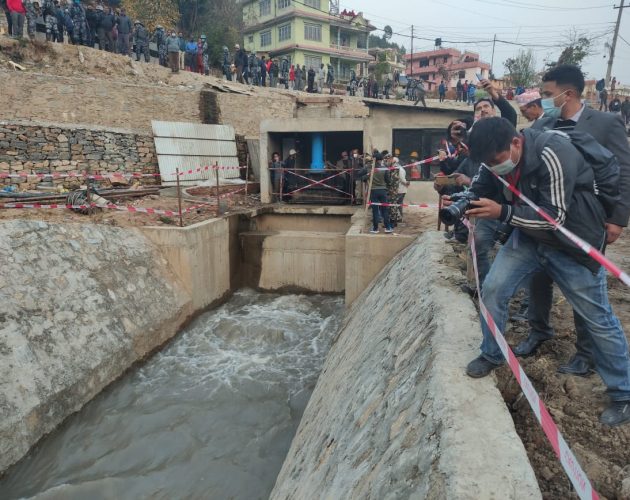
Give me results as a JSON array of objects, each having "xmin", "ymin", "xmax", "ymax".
[{"xmin": 536, "ymin": 130, "xmax": 621, "ymax": 217}]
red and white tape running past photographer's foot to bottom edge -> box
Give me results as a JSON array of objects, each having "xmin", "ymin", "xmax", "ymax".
[{"xmin": 470, "ymin": 219, "xmax": 599, "ymax": 500}]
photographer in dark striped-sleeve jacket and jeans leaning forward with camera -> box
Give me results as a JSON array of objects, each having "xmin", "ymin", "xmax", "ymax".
[{"xmin": 466, "ymin": 118, "xmax": 630, "ymax": 426}]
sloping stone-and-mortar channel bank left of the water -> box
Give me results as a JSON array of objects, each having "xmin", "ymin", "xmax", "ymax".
[{"xmin": 0, "ymin": 220, "xmax": 193, "ymax": 471}]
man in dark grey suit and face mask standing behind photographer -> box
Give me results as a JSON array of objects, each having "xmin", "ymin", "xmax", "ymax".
[{"xmin": 514, "ymin": 65, "xmax": 630, "ymax": 370}]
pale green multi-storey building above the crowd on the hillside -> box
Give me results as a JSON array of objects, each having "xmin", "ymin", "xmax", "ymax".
[{"xmin": 243, "ymin": 0, "xmax": 376, "ymax": 81}]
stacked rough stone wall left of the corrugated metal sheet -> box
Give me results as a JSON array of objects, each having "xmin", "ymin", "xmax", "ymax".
[{"xmin": 0, "ymin": 121, "xmax": 159, "ymax": 190}]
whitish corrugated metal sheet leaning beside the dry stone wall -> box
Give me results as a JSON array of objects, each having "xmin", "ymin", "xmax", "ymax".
[{"xmin": 151, "ymin": 121, "xmax": 240, "ymax": 186}]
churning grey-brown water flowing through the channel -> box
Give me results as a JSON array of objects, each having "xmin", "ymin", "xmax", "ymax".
[{"xmin": 0, "ymin": 290, "xmax": 343, "ymax": 500}]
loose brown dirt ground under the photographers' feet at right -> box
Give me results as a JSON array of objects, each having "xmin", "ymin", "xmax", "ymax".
[{"xmin": 444, "ymin": 231, "xmax": 630, "ymax": 500}]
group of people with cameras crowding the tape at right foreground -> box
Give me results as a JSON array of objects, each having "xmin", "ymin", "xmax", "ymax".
[{"xmin": 437, "ymin": 65, "xmax": 630, "ymax": 426}]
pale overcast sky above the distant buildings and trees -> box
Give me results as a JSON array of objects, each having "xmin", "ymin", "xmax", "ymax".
[{"xmin": 340, "ymin": 0, "xmax": 630, "ymax": 85}]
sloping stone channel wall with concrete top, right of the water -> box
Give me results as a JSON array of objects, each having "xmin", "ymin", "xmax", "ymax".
[{"xmin": 271, "ymin": 233, "xmax": 541, "ymax": 500}]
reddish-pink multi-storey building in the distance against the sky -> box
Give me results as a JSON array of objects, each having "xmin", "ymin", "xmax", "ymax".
[{"xmin": 405, "ymin": 49, "xmax": 490, "ymax": 90}]
